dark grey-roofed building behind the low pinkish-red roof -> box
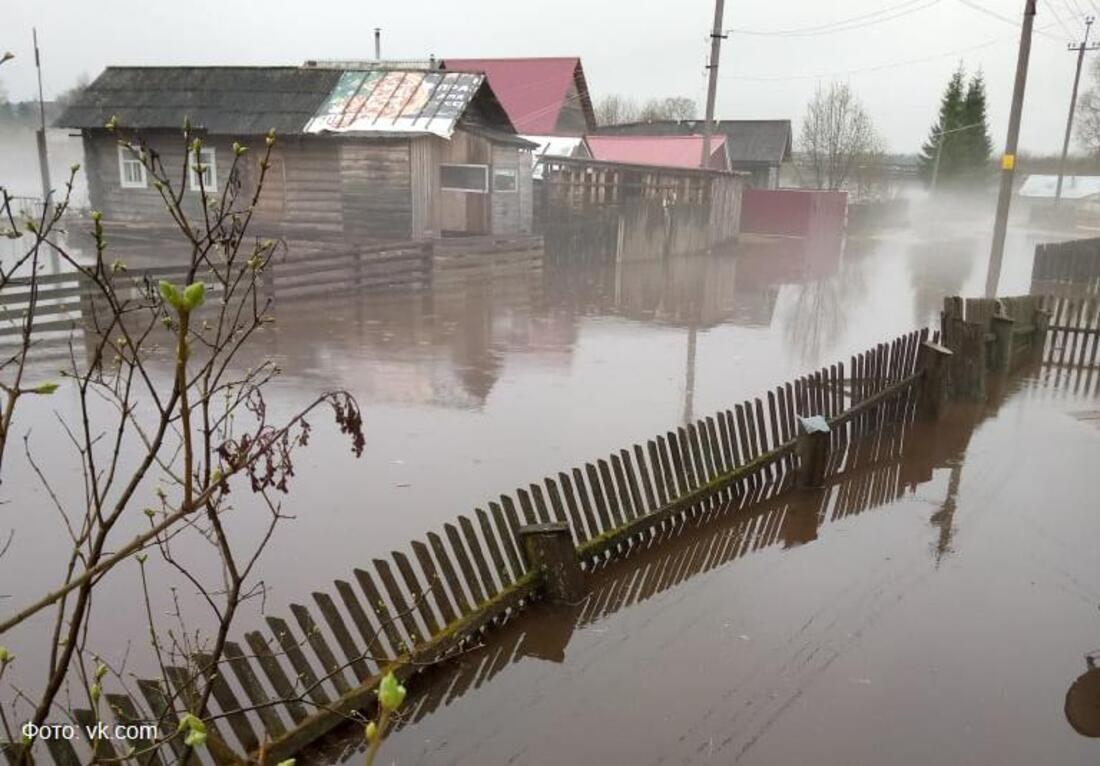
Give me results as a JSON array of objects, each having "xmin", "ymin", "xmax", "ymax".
[{"xmin": 596, "ymin": 120, "xmax": 791, "ymax": 189}]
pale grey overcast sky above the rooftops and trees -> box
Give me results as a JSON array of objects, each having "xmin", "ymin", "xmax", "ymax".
[{"xmin": 0, "ymin": 0, "xmax": 1100, "ymax": 152}]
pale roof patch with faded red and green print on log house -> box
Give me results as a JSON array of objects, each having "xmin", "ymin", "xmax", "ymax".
[{"xmin": 305, "ymin": 69, "xmax": 485, "ymax": 139}]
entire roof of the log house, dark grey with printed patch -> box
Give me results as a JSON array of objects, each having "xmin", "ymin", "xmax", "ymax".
[{"xmin": 56, "ymin": 66, "xmax": 530, "ymax": 140}]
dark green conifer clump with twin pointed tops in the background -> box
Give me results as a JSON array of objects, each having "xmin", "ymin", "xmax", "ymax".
[{"xmin": 920, "ymin": 64, "xmax": 993, "ymax": 185}]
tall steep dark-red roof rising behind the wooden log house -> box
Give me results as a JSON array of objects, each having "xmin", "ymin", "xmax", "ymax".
[{"xmin": 443, "ymin": 56, "xmax": 592, "ymax": 135}]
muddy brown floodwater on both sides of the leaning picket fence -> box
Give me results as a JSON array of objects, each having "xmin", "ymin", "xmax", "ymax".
[{"xmin": 0, "ymin": 195, "xmax": 1100, "ymax": 764}]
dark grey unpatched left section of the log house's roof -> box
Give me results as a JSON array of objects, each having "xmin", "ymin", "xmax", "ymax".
[{"xmin": 55, "ymin": 66, "xmax": 341, "ymax": 135}]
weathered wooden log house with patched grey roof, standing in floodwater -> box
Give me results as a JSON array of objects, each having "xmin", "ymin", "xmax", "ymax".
[{"xmin": 57, "ymin": 66, "xmax": 535, "ymax": 242}]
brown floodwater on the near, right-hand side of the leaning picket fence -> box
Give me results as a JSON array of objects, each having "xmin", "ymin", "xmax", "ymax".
[{"xmin": 304, "ymin": 373, "xmax": 1100, "ymax": 765}]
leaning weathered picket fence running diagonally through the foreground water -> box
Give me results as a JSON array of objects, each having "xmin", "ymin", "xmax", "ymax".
[{"xmin": 12, "ymin": 323, "xmax": 946, "ymax": 764}]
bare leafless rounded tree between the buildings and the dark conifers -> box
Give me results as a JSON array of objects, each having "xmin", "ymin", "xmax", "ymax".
[{"xmin": 799, "ymin": 83, "xmax": 882, "ymax": 189}]
